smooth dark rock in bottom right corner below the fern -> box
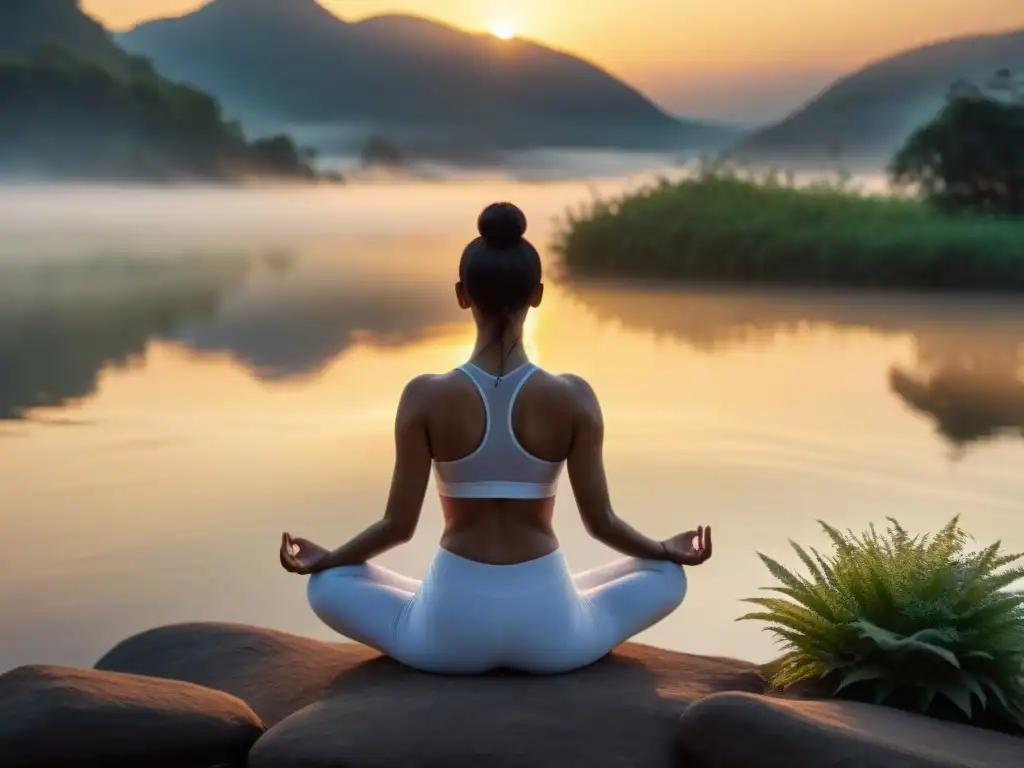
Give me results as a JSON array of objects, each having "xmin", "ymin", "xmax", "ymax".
[{"xmin": 671, "ymin": 693, "xmax": 1024, "ymax": 768}]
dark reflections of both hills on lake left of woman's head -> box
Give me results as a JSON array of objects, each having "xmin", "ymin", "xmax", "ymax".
[{"xmin": 0, "ymin": 254, "xmax": 458, "ymax": 423}]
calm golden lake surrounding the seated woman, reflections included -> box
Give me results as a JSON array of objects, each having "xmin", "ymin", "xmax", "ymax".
[{"xmin": 0, "ymin": 179, "xmax": 1024, "ymax": 670}]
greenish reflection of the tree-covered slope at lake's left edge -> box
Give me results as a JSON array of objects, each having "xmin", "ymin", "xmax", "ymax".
[{"xmin": 0, "ymin": 257, "xmax": 246, "ymax": 420}]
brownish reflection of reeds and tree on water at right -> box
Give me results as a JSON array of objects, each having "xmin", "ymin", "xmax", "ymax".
[{"xmin": 569, "ymin": 283, "xmax": 1024, "ymax": 456}]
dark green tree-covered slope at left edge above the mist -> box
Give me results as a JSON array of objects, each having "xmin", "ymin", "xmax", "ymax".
[{"xmin": 0, "ymin": 46, "xmax": 314, "ymax": 179}]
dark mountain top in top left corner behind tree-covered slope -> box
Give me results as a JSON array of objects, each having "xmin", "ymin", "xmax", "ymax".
[{"xmin": 0, "ymin": 0, "xmax": 129, "ymax": 70}]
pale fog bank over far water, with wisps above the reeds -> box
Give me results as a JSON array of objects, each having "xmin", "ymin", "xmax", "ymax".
[{"xmin": 0, "ymin": 158, "xmax": 889, "ymax": 263}]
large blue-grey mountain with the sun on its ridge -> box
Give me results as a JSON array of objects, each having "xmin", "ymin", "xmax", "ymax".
[{"xmin": 119, "ymin": 0, "xmax": 734, "ymax": 154}]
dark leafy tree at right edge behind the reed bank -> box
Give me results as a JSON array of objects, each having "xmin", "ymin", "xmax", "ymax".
[{"xmin": 889, "ymin": 70, "xmax": 1024, "ymax": 216}]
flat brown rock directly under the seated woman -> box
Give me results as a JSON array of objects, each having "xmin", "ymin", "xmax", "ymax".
[{"xmin": 249, "ymin": 645, "xmax": 763, "ymax": 768}]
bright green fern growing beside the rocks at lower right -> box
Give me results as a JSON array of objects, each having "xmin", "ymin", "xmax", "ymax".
[{"xmin": 739, "ymin": 518, "xmax": 1024, "ymax": 728}]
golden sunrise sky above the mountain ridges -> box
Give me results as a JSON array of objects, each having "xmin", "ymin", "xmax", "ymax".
[{"xmin": 82, "ymin": 0, "xmax": 1024, "ymax": 121}]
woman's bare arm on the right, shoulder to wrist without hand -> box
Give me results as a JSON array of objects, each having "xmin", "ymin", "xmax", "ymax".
[{"xmin": 565, "ymin": 377, "xmax": 673, "ymax": 560}]
